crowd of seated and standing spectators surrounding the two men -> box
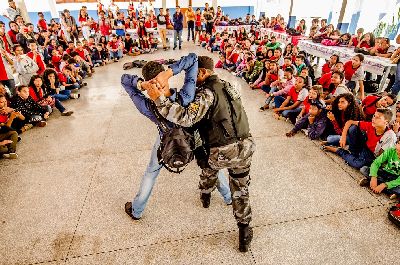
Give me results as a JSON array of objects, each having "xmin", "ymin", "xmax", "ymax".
[{"xmin": 0, "ymin": 0, "xmax": 400, "ymax": 202}]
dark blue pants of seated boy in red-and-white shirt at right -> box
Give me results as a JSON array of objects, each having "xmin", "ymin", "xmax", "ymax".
[{"xmin": 336, "ymin": 125, "xmax": 375, "ymax": 169}]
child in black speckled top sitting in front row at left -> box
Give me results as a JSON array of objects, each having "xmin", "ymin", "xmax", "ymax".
[{"xmin": 11, "ymin": 86, "xmax": 50, "ymax": 127}]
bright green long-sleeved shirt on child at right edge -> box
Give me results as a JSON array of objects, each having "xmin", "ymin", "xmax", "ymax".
[{"xmin": 369, "ymin": 147, "xmax": 400, "ymax": 189}]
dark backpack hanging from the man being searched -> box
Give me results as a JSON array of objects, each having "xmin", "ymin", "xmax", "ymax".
[{"xmin": 151, "ymin": 103, "xmax": 195, "ymax": 173}]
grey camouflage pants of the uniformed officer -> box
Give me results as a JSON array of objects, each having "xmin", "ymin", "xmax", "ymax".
[{"xmin": 199, "ymin": 137, "xmax": 255, "ymax": 224}]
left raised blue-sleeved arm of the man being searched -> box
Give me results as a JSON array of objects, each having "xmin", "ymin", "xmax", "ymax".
[{"xmin": 121, "ymin": 74, "xmax": 157, "ymax": 123}]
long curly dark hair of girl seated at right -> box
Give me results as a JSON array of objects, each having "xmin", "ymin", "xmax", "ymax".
[{"xmin": 332, "ymin": 93, "xmax": 364, "ymax": 128}]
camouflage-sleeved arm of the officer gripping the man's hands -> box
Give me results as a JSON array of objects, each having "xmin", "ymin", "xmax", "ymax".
[{"xmin": 154, "ymin": 89, "xmax": 214, "ymax": 127}]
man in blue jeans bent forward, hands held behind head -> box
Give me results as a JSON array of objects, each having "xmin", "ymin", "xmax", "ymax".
[{"xmin": 121, "ymin": 53, "xmax": 232, "ymax": 220}]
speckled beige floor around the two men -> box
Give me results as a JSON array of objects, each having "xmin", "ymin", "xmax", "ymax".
[{"xmin": 0, "ymin": 43, "xmax": 400, "ymax": 264}]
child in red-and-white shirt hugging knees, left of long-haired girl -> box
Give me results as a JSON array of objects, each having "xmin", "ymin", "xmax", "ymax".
[{"xmin": 274, "ymin": 76, "xmax": 308, "ymax": 124}]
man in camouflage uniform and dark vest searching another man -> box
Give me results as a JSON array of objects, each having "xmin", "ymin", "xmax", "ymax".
[{"xmin": 147, "ymin": 56, "xmax": 255, "ymax": 252}]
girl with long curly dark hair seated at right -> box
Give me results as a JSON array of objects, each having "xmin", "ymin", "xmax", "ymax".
[{"xmin": 321, "ymin": 92, "xmax": 364, "ymax": 146}]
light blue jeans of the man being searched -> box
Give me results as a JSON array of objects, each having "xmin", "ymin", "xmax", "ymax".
[{"xmin": 132, "ymin": 136, "xmax": 232, "ymax": 218}]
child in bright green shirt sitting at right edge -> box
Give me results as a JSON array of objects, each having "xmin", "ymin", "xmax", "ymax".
[{"xmin": 359, "ymin": 141, "xmax": 400, "ymax": 199}]
